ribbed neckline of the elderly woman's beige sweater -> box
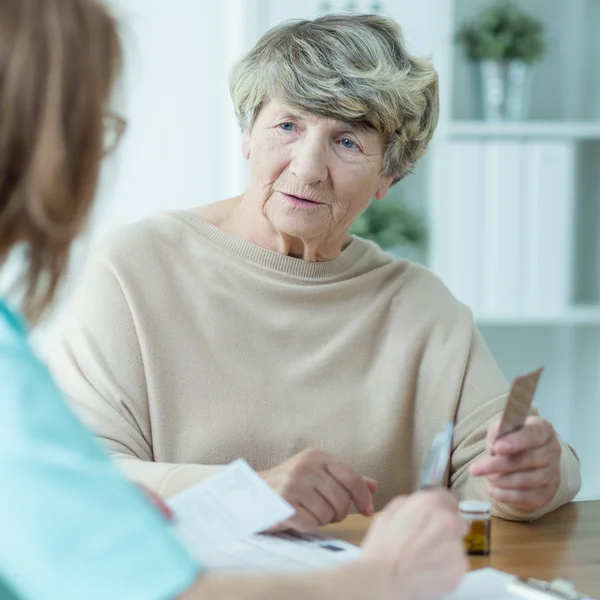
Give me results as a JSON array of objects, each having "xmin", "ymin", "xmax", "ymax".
[{"xmin": 171, "ymin": 210, "xmax": 372, "ymax": 281}]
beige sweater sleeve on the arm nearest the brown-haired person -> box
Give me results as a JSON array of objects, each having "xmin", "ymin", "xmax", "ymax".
[{"xmin": 48, "ymin": 252, "xmax": 220, "ymax": 497}]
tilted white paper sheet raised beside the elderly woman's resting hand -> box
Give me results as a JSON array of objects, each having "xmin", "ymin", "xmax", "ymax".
[{"xmin": 168, "ymin": 459, "xmax": 295, "ymax": 565}]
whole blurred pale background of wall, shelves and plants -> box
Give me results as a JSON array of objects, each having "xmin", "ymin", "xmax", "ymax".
[{"xmin": 37, "ymin": 0, "xmax": 600, "ymax": 499}]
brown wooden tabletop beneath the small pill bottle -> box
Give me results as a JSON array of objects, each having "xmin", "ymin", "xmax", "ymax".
[{"xmin": 324, "ymin": 501, "xmax": 600, "ymax": 600}]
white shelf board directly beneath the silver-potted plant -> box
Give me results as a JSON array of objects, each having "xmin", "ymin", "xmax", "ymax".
[{"xmin": 445, "ymin": 121, "xmax": 600, "ymax": 140}]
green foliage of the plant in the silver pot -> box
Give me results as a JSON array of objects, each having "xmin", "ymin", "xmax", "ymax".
[{"xmin": 456, "ymin": 0, "xmax": 546, "ymax": 63}]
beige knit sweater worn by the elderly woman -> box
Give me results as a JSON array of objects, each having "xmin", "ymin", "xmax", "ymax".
[{"xmin": 50, "ymin": 212, "xmax": 580, "ymax": 519}]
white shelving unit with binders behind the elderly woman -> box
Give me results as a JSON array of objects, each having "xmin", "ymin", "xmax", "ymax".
[{"xmin": 254, "ymin": 0, "xmax": 600, "ymax": 499}]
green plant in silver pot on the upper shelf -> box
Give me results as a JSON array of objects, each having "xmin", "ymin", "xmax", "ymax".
[{"xmin": 456, "ymin": 0, "xmax": 546, "ymax": 121}]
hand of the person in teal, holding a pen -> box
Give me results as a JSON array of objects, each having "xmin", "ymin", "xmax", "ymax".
[{"xmin": 363, "ymin": 490, "xmax": 467, "ymax": 600}]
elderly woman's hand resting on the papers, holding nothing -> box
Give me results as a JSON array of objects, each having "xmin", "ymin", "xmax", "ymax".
[{"xmin": 260, "ymin": 449, "xmax": 377, "ymax": 533}]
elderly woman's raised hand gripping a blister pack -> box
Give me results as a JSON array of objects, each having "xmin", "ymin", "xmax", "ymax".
[{"xmin": 470, "ymin": 417, "xmax": 561, "ymax": 512}]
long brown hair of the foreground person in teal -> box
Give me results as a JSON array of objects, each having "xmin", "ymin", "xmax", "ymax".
[{"xmin": 0, "ymin": 0, "xmax": 121, "ymax": 321}]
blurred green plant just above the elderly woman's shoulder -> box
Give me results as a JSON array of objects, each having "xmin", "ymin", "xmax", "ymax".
[{"xmin": 350, "ymin": 198, "xmax": 427, "ymax": 250}]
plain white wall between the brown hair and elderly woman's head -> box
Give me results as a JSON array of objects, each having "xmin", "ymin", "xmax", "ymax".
[{"xmin": 34, "ymin": 0, "xmax": 252, "ymax": 352}]
